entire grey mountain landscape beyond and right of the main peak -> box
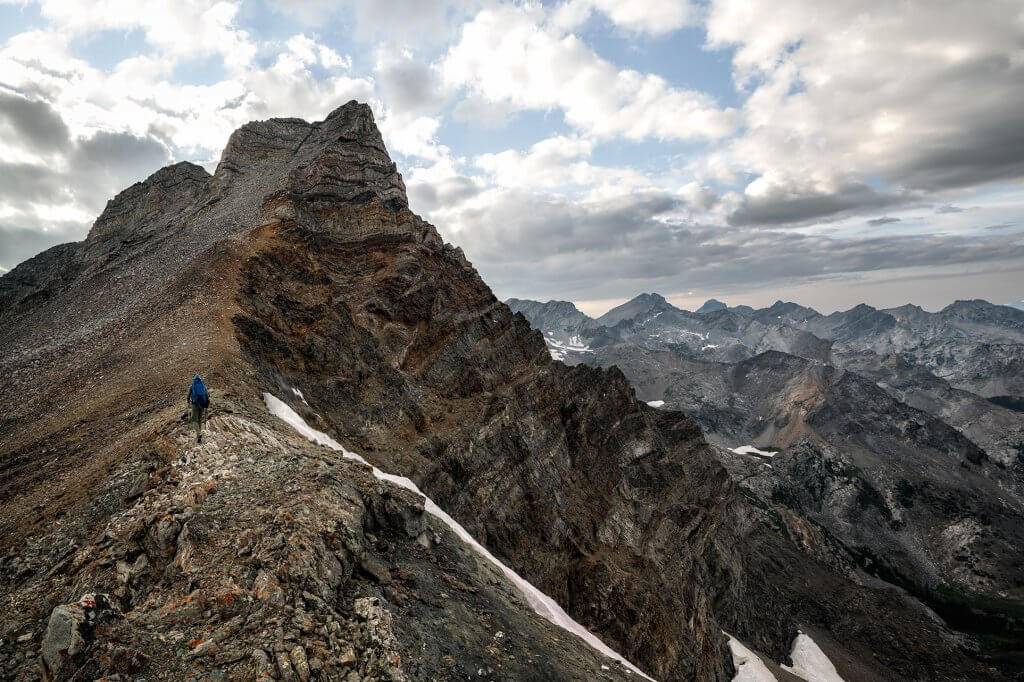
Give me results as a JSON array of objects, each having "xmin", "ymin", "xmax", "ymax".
[{"xmin": 508, "ymin": 293, "xmax": 1024, "ymax": 665}]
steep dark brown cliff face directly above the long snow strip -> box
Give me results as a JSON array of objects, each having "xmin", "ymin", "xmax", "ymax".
[{"xmin": 234, "ymin": 142, "xmax": 745, "ymax": 679}]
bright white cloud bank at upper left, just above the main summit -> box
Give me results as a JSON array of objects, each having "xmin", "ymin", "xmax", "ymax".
[{"xmin": 0, "ymin": 21, "xmax": 375, "ymax": 156}]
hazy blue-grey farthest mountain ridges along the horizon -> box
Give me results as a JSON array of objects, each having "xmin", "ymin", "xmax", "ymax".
[{"xmin": 508, "ymin": 294, "xmax": 1024, "ymax": 398}]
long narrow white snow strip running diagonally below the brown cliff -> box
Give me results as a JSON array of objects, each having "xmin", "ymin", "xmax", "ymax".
[{"xmin": 263, "ymin": 393, "xmax": 653, "ymax": 682}]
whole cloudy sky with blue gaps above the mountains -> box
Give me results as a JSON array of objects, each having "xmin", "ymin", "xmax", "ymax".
[{"xmin": 0, "ymin": 0, "xmax": 1024, "ymax": 312}]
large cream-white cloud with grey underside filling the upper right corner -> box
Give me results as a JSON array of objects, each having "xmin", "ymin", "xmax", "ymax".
[{"xmin": 707, "ymin": 0, "xmax": 1024, "ymax": 222}]
